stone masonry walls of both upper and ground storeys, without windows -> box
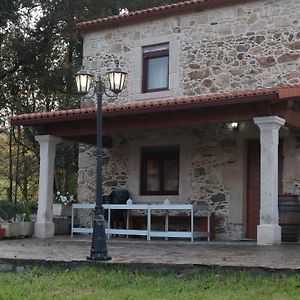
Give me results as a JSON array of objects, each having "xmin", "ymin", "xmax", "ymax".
[{"xmin": 78, "ymin": 0, "xmax": 300, "ymax": 239}]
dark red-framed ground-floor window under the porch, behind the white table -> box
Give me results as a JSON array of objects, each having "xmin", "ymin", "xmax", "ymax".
[{"xmin": 141, "ymin": 146, "xmax": 179, "ymax": 195}]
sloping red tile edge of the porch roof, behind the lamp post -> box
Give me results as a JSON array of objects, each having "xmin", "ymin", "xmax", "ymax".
[{"xmin": 11, "ymin": 85, "xmax": 300, "ymax": 126}]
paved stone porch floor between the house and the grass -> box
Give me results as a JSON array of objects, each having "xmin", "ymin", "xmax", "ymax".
[{"xmin": 0, "ymin": 235, "xmax": 300, "ymax": 271}]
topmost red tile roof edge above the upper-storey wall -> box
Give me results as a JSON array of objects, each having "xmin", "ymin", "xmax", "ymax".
[{"xmin": 76, "ymin": 0, "xmax": 257, "ymax": 34}]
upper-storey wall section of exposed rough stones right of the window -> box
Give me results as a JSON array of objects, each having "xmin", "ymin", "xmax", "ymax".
[{"xmin": 180, "ymin": 0, "xmax": 300, "ymax": 95}]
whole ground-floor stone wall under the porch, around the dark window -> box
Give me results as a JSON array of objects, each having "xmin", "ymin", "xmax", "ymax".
[{"xmin": 78, "ymin": 125, "xmax": 244, "ymax": 239}]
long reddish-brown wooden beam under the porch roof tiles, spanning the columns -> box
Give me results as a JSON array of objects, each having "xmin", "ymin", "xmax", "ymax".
[{"xmin": 37, "ymin": 101, "xmax": 289, "ymax": 137}]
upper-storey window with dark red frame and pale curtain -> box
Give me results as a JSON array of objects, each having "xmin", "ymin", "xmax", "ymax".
[{"xmin": 142, "ymin": 43, "xmax": 169, "ymax": 93}]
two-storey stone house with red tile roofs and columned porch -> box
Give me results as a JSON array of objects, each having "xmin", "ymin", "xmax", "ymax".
[{"xmin": 12, "ymin": 0, "xmax": 300, "ymax": 244}]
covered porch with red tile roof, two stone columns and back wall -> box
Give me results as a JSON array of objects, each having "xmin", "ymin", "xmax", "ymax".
[{"xmin": 11, "ymin": 86, "xmax": 300, "ymax": 245}]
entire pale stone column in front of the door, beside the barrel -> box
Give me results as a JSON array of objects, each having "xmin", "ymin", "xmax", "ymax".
[{"xmin": 254, "ymin": 116, "xmax": 285, "ymax": 245}]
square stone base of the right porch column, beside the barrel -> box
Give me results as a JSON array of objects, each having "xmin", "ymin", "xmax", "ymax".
[{"xmin": 257, "ymin": 224, "xmax": 281, "ymax": 245}]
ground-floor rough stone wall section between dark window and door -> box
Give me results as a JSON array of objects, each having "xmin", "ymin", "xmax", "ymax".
[{"xmin": 189, "ymin": 126, "xmax": 244, "ymax": 239}]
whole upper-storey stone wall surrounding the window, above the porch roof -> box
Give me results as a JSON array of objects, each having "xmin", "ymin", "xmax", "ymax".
[{"xmin": 84, "ymin": 0, "xmax": 300, "ymax": 101}]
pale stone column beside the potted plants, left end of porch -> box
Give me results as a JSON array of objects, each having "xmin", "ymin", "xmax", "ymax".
[{"xmin": 34, "ymin": 135, "xmax": 61, "ymax": 239}]
